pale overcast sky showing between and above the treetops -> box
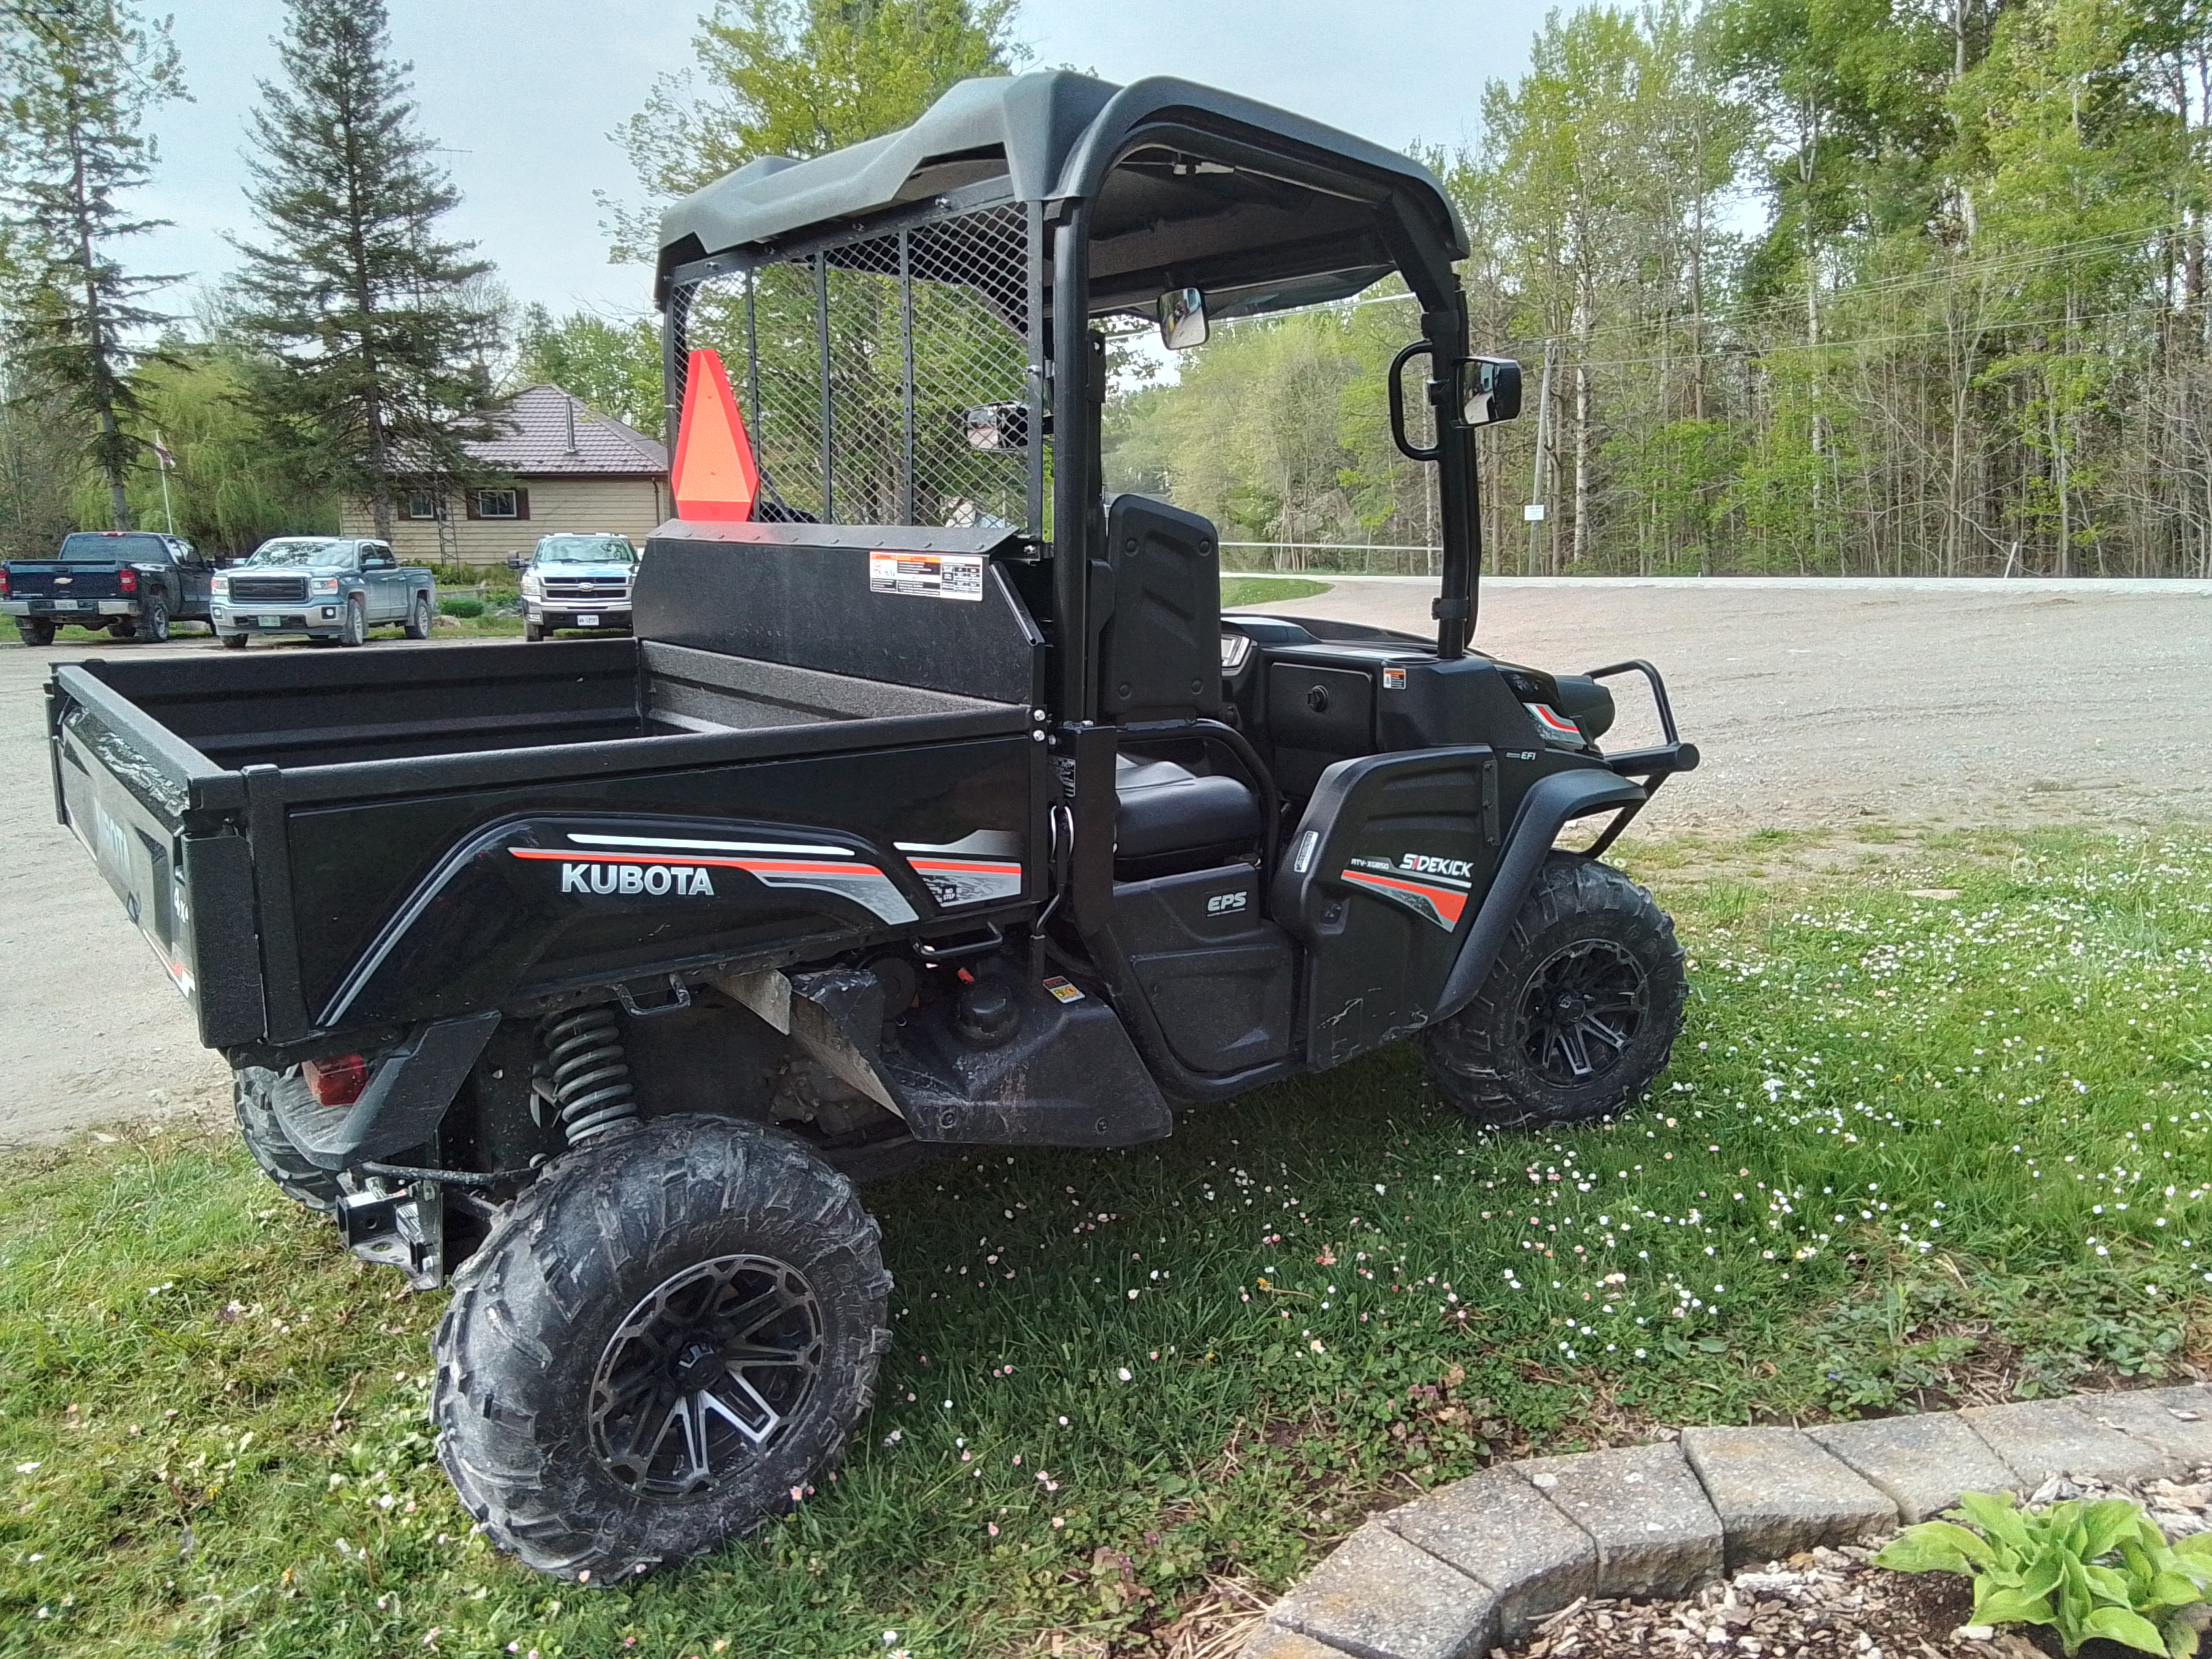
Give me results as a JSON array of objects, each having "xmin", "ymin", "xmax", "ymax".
[{"xmin": 133, "ymin": 0, "xmax": 1544, "ymax": 327}]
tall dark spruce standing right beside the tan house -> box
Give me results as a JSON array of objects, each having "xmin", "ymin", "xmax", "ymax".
[{"xmin": 239, "ymin": 0, "xmax": 497, "ymax": 535}]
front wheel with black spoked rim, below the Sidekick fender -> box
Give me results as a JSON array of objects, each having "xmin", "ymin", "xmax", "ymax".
[{"xmin": 1422, "ymin": 852, "xmax": 1690, "ymax": 1128}]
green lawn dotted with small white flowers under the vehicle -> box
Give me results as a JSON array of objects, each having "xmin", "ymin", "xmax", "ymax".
[{"xmin": 0, "ymin": 832, "xmax": 2212, "ymax": 1659}]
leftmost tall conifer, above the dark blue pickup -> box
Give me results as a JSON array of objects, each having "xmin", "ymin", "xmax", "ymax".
[{"xmin": 0, "ymin": 0, "xmax": 184, "ymax": 531}]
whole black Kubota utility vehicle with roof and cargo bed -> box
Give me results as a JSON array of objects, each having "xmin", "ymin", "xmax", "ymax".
[{"xmin": 51, "ymin": 73, "xmax": 1696, "ymax": 1584}]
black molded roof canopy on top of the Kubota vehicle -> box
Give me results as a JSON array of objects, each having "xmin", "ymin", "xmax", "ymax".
[{"xmin": 655, "ymin": 70, "xmax": 1467, "ymax": 316}]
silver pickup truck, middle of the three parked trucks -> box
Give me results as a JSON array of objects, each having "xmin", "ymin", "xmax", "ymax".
[{"xmin": 212, "ymin": 535, "xmax": 438, "ymax": 651}]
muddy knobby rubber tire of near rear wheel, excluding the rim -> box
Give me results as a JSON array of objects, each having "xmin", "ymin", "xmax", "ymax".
[{"xmin": 431, "ymin": 1117, "xmax": 891, "ymax": 1586}]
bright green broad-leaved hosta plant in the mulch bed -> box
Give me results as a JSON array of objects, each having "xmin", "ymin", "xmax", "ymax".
[{"xmin": 1874, "ymin": 1493, "xmax": 2212, "ymax": 1659}]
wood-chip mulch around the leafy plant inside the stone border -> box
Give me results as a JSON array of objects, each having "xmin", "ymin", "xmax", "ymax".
[{"xmin": 1491, "ymin": 1469, "xmax": 2212, "ymax": 1659}]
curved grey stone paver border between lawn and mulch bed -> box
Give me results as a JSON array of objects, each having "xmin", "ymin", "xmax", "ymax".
[{"xmin": 1243, "ymin": 1382, "xmax": 2212, "ymax": 1659}]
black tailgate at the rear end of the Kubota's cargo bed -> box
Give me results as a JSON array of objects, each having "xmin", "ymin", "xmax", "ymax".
[{"xmin": 47, "ymin": 665, "xmax": 266, "ymax": 1048}]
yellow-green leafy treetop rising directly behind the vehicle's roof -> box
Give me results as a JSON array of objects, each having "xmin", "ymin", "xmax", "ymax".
[{"xmin": 602, "ymin": 0, "xmax": 1029, "ymax": 259}]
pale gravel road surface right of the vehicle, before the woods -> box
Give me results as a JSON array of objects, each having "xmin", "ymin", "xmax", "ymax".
[{"xmin": 1265, "ymin": 579, "xmax": 2212, "ymax": 830}]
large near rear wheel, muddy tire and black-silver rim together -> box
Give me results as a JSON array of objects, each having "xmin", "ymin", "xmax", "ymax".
[{"xmin": 431, "ymin": 1115, "xmax": 891, "ymax": 1584}]
